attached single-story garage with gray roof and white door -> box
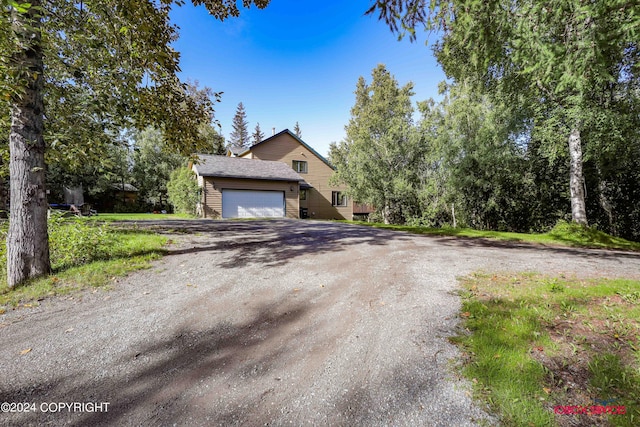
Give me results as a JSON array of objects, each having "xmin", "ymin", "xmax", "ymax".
[{"xmin": 192, "ymin": 154, "xmax": 302, "ymax": 218}]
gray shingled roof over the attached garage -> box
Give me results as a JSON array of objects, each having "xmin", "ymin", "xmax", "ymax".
[{"xmin": 194, "ymin": 154, "xmax": 303, "ymax": 181}]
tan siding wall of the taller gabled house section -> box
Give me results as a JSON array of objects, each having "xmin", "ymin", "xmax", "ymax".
[{"xmin": 243, "ymin": 133, "xmax": 353, "ymax": 219}]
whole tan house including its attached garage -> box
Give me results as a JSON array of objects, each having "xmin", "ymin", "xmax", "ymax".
[{"xmin": 192, "ymin": 129, "xmax": 353, "ymax": 219}]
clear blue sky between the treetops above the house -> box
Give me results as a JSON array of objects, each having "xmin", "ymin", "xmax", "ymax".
[{"xmin": 171, "ymin": 0, "xmax": 444, "ymax": 155}]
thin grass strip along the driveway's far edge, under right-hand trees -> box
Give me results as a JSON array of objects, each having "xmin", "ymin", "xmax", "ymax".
[{"xmin": 342, "ymin": 221, "xmax": 640, "ymax": 251}]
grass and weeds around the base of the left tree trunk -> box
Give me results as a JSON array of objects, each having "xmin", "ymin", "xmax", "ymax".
[{"xmin": 0, "ymin": 219, "xmax": 167, "ymax": 313}]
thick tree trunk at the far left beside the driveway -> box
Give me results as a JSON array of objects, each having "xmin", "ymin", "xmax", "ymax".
[{"xmin": 7, "ymin": 0, "xmax": 51, "ymax": 288}]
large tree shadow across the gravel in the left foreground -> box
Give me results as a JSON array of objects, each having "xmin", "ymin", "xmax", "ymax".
[{"xmin": 0, "ymin": 303, "xmax": 312, "ymax": 426}]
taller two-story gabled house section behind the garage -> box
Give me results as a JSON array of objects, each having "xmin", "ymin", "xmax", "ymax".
[{"xmin": 239, "ymin": 129, "xmax": 353, "ymax": 219}]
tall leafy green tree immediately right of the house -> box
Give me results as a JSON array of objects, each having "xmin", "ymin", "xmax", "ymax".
[{"xmin": 329, "ymin": 65, "xmax": 424, "ymax": 224}]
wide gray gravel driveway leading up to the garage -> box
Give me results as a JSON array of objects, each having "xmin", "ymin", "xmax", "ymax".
[{"xmin": 0, "ymin": 220, "xmax": 640, "ymax": 426}]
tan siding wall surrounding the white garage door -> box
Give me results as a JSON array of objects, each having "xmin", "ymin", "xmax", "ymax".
[{"xmin": 198, "ymin": 176, "xmax": 300, "ymax": 219}]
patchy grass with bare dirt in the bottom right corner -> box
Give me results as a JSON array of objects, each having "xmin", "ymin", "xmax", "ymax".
[{"xmin": 453, "ymin": 274, "xmax": 640, "ymax": 426}]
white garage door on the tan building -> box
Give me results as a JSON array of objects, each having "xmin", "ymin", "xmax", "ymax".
[{"xmin": 222, "ymin": 189, "xmax": 284, "ymax": 218}]
